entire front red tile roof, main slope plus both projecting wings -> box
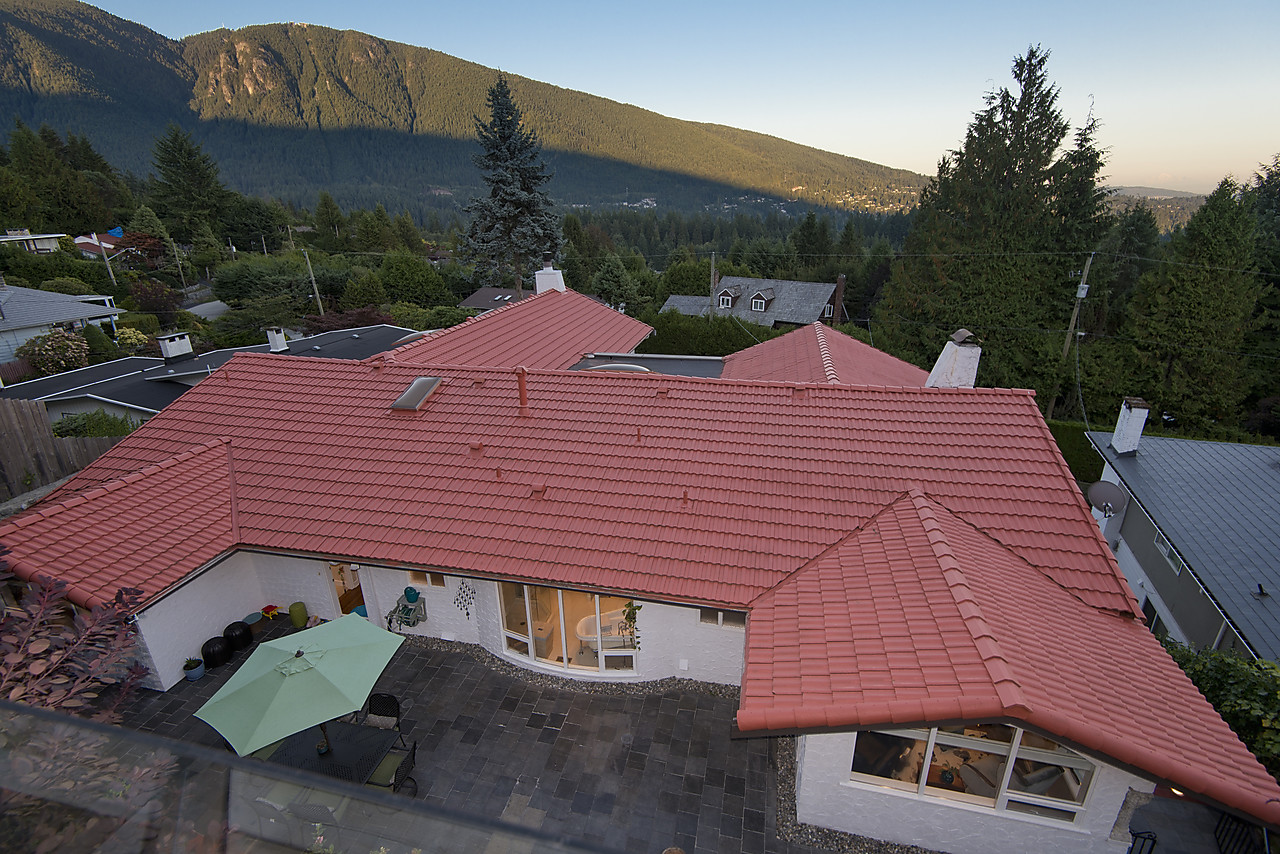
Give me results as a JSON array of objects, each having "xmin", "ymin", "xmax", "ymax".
[{"xmin": 0, "ymin": 355, "xmax": 1280, "ymax": 821}]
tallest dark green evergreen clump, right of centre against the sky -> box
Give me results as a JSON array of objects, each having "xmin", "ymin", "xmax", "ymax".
[{"xmin": 876, "ymin": 46, "xmax": 1110, "ymax": 401}]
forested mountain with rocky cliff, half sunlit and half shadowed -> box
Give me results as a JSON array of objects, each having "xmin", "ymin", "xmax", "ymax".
[{"xmin": 0, "ymin": 0, "xmax": 927, "ymax": 219}]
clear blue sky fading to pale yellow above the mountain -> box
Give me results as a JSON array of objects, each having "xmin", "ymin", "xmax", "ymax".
[{"xmin": 95, "ymin": 0, "xmax": 1280, "ymax": 192}]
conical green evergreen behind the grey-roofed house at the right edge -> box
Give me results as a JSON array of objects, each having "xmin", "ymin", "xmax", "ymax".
[{"xmin": 1128, "ymin": 179, "xmax": 1261, "ymax": 435}]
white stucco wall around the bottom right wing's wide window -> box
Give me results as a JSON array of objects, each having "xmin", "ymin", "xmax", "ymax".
[{"xmin": 796, "ymin": 732, "xmax": 1155, "ymax": 854}]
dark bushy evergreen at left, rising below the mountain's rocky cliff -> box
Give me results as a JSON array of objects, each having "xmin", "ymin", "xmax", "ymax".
[{"xmin": 152, "ymin": 123, "xmax": 229, "ymax": 241}]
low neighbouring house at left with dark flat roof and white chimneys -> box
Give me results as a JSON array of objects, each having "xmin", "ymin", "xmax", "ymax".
[{"xmin": 0, "ymin": 324, "xmax": 412, "ymax": 421}]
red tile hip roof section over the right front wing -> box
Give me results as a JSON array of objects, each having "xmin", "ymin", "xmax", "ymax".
[{"xmin": 737, "ymin": 489, "xmax": 1280, "ymax": 825}]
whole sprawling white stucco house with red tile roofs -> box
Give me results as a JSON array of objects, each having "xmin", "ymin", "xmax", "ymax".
[{"xmin": 0, "ymin": 306, "xmax": 1280, "ymax": 854}]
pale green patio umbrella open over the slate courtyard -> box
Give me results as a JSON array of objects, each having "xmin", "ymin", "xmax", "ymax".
[{"xmin": 196, "ymin": 613, "xmax": 404, "ymax": 755}]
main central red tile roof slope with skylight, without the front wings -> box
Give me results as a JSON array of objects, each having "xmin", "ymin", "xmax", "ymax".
[{"xmin": 17, "ymin": 358, "xmax": 1137, "ymax": 612}]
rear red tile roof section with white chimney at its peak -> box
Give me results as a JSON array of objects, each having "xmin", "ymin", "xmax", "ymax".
[{"xmin": 386, "ymin": 291, "xmax": 653, "ymax": 369}]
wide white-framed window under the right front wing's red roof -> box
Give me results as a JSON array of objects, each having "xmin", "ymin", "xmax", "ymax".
[{"xmin": 850, "ymin": 723, "xmax": 1094, "ymax": 822}]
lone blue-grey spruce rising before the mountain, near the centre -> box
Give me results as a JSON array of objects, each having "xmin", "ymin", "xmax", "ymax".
[{"xmin": 462, "ymin": 74, "xmax": 561, "ymax": 293}]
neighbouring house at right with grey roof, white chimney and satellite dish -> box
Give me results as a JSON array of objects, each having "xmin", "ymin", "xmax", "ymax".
[{"xmin": 1088, "ymin": 398, "xmax": 1280, "ymax": 661}]
